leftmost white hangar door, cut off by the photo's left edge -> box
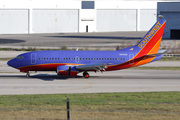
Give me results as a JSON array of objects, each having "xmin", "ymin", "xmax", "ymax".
[{"xmin": 0, "ymin": 9, "xmax": 29, "ymax": 34}]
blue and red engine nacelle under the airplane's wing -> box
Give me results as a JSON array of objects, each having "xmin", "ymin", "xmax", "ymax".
[{"xmin": 57, "ymin": 65, "xmax": 78, "ymax": 76}]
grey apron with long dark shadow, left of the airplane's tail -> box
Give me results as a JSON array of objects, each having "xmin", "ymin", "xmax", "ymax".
[{"xmin": 0, "ymin": 32, "xmax": 146, "ymax": 48}]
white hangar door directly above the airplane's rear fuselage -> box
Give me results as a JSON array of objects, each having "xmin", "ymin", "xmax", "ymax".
[{"xmin": 96, "ymin": 9, "xmax": 137, "ymax": 32}]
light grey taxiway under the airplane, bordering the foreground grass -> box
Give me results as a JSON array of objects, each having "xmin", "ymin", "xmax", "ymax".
[{"xmin": 0, "ymin": 69, "xmax": 180, "ymax": 95}]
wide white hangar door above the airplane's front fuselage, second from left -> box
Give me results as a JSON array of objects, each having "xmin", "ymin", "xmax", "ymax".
[{"xmin": 33, "ymin": 9, "xmax": 79, "ymax": 33}]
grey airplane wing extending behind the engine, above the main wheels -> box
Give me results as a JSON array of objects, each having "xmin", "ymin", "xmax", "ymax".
[{"xmin": 76, "ymin": 63, "xmax": 107, "ymax": 71}]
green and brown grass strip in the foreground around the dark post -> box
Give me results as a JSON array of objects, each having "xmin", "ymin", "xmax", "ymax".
[{"xmin": 0, "ymin": 92, "xmax": 180, "ymax": 120}]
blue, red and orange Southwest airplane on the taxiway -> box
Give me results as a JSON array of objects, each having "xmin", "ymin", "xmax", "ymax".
[{"xmin": 7, "ymin": 19, "xmax": 166, "ymax": 78}]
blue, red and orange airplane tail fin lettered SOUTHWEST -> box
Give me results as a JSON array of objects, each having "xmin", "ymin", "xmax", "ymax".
[{"xmin": 133, "ymin": 19, "xmax": 166, "ymax": 67}]
